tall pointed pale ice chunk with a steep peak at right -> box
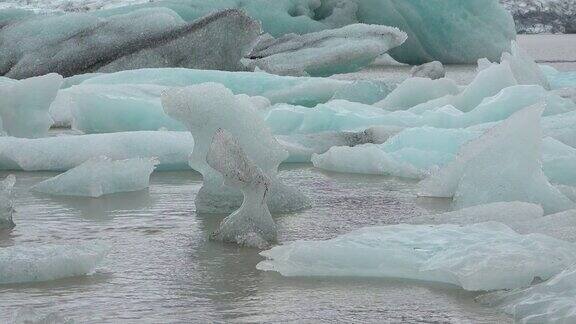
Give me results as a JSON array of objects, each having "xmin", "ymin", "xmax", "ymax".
[{"xmin": 421, "ymin": 105, "xmax": 574, "ymax": 213}]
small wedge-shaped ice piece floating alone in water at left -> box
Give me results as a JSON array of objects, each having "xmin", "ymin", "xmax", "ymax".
[{"xmin": 33, "ymin": 156, "xmax": 159, "ymax": 198}]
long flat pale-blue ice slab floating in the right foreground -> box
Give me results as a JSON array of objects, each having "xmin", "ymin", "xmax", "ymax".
[{"xmin": 257, "ymin": 222, "xmax": 576, "ymax": 291}]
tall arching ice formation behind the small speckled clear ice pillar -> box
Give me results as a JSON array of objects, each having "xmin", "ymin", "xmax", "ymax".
[{"xmin": 162, "ymin": 83, "xmax": 310, "ymax": 213}]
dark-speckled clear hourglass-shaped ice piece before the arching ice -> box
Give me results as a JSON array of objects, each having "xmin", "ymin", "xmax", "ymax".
[{"xmin": 206, "ymin": 129, "xmax": 277, "ymax": 249}]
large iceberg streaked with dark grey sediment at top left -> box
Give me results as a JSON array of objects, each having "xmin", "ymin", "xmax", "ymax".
[{"xmin": 0, "ymin": 8, "xmax": 261, "ymax": 79}]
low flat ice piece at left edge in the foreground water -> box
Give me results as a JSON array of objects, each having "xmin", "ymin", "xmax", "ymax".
[{"xmin": 0, "ymin": 243, "xmax": 108, "ymax": 284}]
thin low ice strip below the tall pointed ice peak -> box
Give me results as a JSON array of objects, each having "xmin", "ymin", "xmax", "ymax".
[{"xmin": 409, "ymin": 201, "xmax": 544, "ymax": 230}]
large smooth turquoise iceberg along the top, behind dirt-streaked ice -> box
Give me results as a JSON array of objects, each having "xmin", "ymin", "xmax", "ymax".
[{"xmin": 96, "ymin": 0, "xmax": 516, "ymax": 64}]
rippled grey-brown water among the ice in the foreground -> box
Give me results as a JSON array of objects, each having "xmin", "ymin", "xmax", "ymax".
[{"xmin": 0, "ymin": 165, "xmax": 509, "ymax": 323}]
